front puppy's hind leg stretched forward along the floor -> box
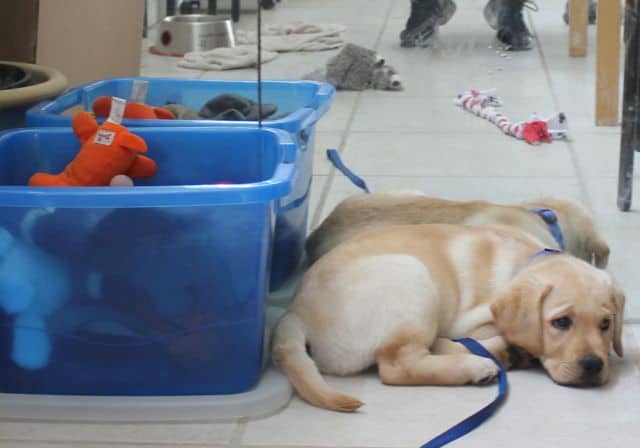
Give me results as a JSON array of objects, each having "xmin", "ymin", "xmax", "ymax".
[{"xmin": 377, "ymin": 339, "xmax": 499, "ymax": 386}]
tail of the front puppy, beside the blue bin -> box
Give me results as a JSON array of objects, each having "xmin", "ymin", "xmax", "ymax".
[{"xmin": 272, "ymin": 313, "xmax": 363, "ymax": 412}]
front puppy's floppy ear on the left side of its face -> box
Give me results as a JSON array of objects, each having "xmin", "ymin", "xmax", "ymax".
[{"xmin": 491, "ymin": 278, "xmax": 553, "ymax": 358}]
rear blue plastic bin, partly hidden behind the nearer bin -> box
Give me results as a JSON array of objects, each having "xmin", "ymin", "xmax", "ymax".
[{"xmin": 27, "ymin": 78, "xmax": 335, "ymax": 289}]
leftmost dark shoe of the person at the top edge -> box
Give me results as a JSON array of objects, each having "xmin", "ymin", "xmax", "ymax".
[{"xmin": 400, "ymin": 0, "xmax": 456, "ymax": 47}]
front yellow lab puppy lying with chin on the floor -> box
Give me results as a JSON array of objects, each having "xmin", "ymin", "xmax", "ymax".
[{"xmin": 272, "ymin": 224, "xmax": 624, "ymax": 411}]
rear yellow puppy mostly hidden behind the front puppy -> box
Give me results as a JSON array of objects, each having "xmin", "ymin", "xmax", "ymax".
[{"xmin": 306, "ymin": 192, "xmax": 609, "ymax": 268}]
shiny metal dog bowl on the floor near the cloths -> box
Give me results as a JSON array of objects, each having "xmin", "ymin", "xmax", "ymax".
[{"xmin": 150, "ymin": 14, "xmax": 235, "ymax": 56}]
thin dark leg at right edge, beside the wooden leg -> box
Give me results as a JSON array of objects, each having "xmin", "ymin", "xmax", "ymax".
[{"xmin": 618, "ymin": 0, "xmax": 640, "ymax": 212}]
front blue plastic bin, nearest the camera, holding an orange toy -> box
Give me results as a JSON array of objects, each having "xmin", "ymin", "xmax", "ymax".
[{"xmin": 0, "ymin": 128, "xmax": 296, "ymax": 395}]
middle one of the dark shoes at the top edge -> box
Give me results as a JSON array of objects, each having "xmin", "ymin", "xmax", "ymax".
[{"xmin": 484, "ymin": 0, "xmax": 538, "ymax": 51}]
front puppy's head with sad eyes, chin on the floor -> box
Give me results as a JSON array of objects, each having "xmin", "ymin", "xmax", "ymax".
[{"xmin": 491, "ymin": 255, "xmax": 625, "ymax": 386}]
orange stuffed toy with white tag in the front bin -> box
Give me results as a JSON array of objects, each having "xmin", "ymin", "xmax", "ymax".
[{"xmin": 29, "ymin": 112, "xmax": 158, "ymax": 187}]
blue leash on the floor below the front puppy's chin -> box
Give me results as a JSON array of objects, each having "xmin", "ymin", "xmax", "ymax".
[{"xmin": 421, "ymin": 338, "xmax": 507, "ymax": 448}]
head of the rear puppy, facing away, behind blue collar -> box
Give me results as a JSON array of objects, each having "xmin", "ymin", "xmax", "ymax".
[{"xmin": 525, "ymin": 198, "xmax": 610, "ymax": 269}]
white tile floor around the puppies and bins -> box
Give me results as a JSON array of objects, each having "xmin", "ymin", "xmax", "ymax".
[{"xmin": 0, "ymin": 0, "xmax": 640, "ymax": 448}]
